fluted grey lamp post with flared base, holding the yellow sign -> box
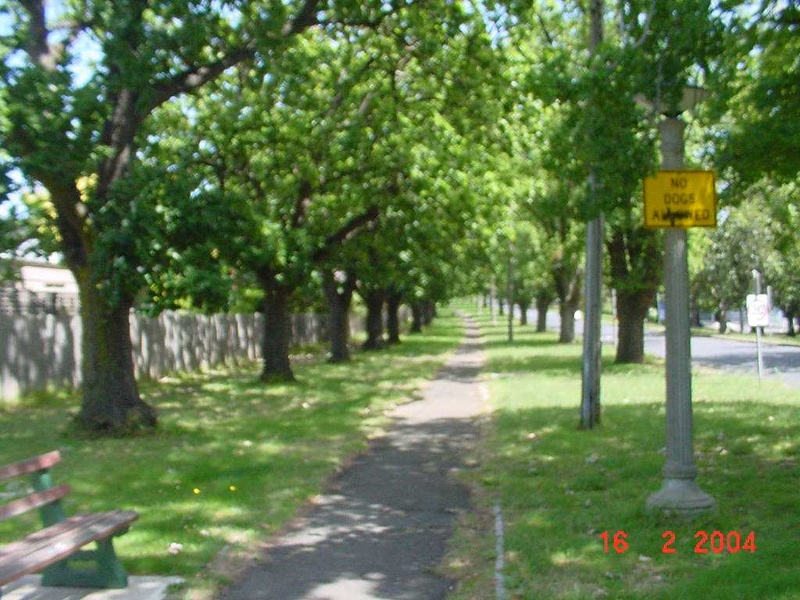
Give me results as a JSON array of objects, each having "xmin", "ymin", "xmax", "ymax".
[{"xmin": 647, "ymin": 113, "xmax": 715, "ymax": 515}]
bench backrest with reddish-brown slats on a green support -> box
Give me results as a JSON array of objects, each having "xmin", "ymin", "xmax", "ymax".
[{"xmin": 0, "ymin": 450, "xmax": 70, "ymax": 526}]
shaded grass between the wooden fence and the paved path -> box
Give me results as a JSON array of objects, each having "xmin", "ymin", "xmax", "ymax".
[{"xmin": 0, "ymin": 311, "xmax": 462, "ymax": 598}]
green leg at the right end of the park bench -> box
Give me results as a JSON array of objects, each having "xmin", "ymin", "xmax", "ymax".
[{"xmin": 42, "ymin": 538, "xmax": 128, "ymax": 588}]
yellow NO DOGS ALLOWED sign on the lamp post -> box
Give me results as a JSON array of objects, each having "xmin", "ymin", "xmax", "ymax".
[{"xmin": 644, "ymin": 171, "xmax": 717, "ymax": 229}]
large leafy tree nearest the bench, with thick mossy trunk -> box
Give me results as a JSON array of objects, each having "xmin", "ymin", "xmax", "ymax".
[{"xmin": 0, "ymin": 0, "xmax": 326, "ymax": 433}]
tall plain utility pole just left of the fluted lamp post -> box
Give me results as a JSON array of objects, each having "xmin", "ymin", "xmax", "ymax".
[{"xmin": 581, "ymin": 0, "xmax": 605, "ymax": 429}]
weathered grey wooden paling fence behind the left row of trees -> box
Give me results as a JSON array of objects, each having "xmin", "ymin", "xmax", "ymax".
[{"xmin": 0, "ymin": 312, "xmax": 352, "ymax": 403}]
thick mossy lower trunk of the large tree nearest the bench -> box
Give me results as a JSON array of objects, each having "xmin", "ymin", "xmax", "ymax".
[{"xmin": 76, "ymin": 269, "xmax": 157, "ymax": 435}]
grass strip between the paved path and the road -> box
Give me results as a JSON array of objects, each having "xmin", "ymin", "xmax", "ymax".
[{"xmin": 449, "ymin": 308, "xmax": 800, "ymax": 600}]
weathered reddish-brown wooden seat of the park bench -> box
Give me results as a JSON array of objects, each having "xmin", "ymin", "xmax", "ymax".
[{"xmin": 0, "ymin": 510, "xmax": 139, "ymax": 586}]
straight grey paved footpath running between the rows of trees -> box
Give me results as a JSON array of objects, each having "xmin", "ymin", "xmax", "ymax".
[{"xmin": 222, "ymin": 321, "xmax": 484, "ymax": 600}]
